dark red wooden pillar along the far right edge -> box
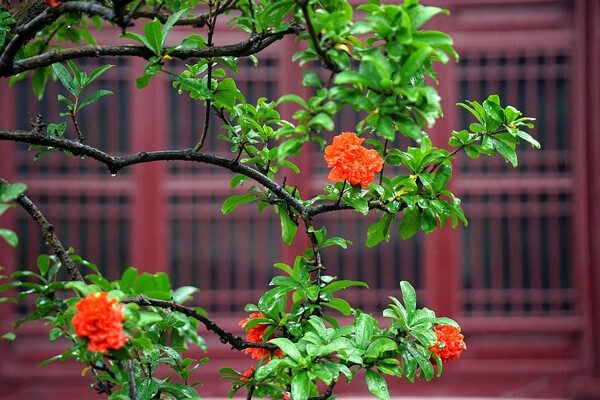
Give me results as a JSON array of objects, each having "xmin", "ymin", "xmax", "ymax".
[{"xmin": 572, "ymin": 0, "xmax": 600, "ymax": 399}]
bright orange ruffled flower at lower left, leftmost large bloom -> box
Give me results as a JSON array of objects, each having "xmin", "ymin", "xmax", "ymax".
[{"xmin": 72, "ymin": 292, "xmax": 127, "ymax": 352}]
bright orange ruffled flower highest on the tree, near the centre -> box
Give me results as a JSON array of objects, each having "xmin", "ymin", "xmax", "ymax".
[{"xmin": 325, "ymin": 132, "xmax": 383, "ymax": 187}]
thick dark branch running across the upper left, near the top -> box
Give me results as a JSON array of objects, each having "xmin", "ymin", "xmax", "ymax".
[{"xmin": 0, "ymin": 24, "xmax": 303, "ymax": 76}]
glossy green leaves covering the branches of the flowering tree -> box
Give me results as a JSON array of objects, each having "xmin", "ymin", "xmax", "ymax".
[{"xmin": 0, "ymin": 0, "xmax": 540, "ymax": 400}]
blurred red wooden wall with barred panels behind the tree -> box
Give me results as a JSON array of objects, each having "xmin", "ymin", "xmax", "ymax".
[{"xmin": 0, "ymin": 0, "xmax": 600, "ymax": 399}]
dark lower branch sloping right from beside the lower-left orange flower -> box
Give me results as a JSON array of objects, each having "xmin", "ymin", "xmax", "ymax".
[{"xmin": 121, "ymin": 294, "xmax": 279, "ymax": 351}]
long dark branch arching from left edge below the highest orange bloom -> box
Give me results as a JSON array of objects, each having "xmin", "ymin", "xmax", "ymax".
[{"xmin": 0, "ymin": 130, "xmax": 308, "ymax": 216}]
